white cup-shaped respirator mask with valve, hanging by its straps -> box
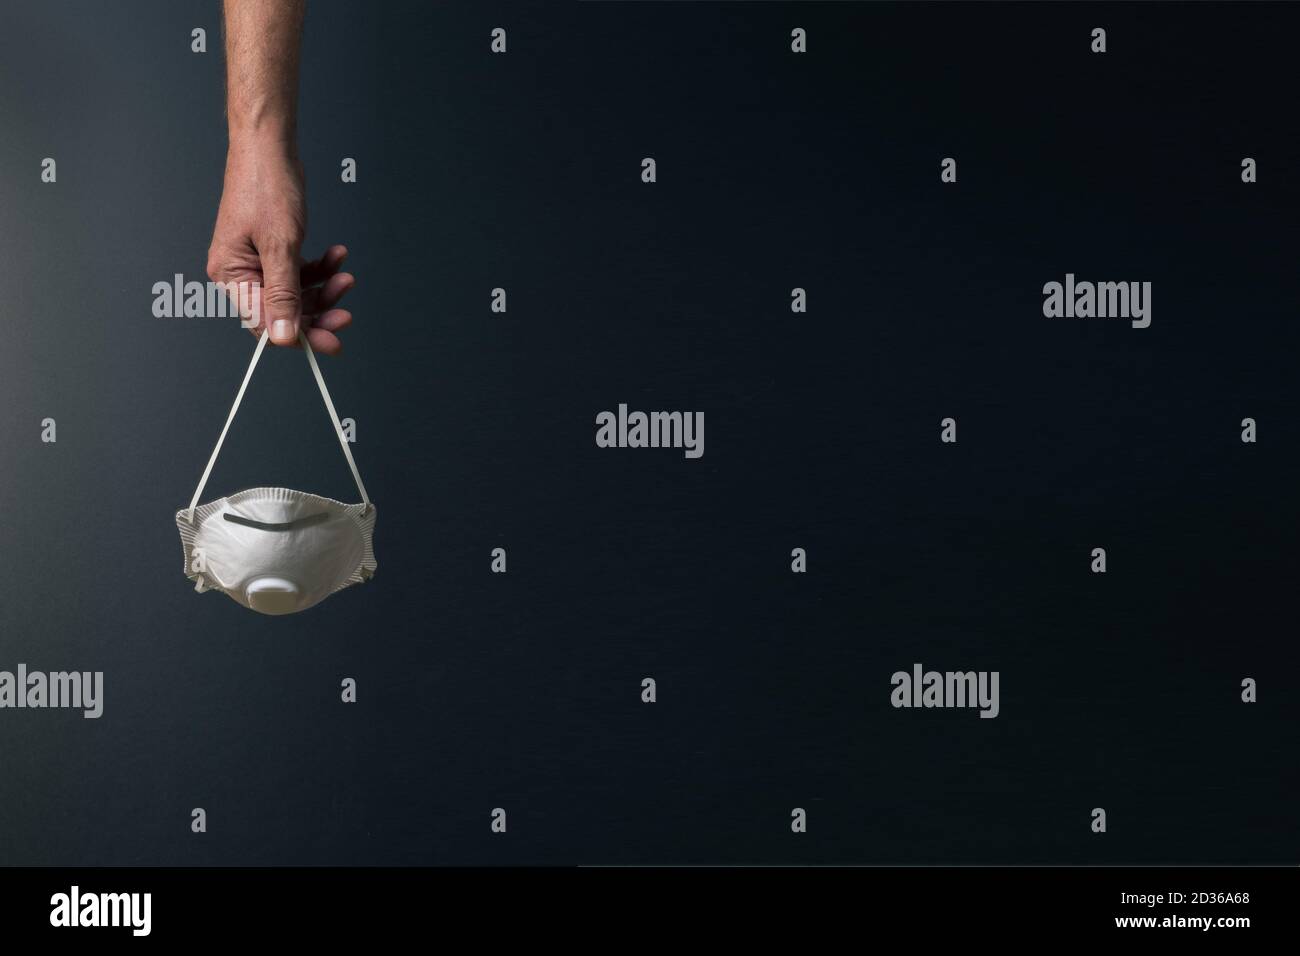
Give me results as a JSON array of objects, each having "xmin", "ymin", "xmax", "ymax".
[{"xmin": 176, "ymin": 332, "xmax": 376, "ymax": 614}]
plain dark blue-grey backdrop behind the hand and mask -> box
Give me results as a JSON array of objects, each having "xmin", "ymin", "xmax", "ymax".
[{"xmin": 0, "ymin": 0, "xmax": 1300, "ymax": 865}]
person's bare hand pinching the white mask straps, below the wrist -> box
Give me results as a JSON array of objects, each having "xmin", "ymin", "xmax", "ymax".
[{"xmin": 208, "ymin": 142, "xmax": 356, "ymax": 355}]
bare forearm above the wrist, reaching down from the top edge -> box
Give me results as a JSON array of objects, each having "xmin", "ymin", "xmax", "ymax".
[{"xmin": 225, "ymin": 0, "xmax": 303, "ymax": 151}]
